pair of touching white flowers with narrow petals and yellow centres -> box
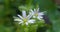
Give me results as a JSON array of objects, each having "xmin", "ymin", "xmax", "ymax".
[{"xmin": 13, "ymin": 8, "xmax": 44, "ymax": 25}]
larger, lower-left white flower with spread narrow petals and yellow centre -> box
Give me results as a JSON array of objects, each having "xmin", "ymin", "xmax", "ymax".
[{"xmin": 13, "ymin": 10, "xmax": 35, "ymax": 25}]
